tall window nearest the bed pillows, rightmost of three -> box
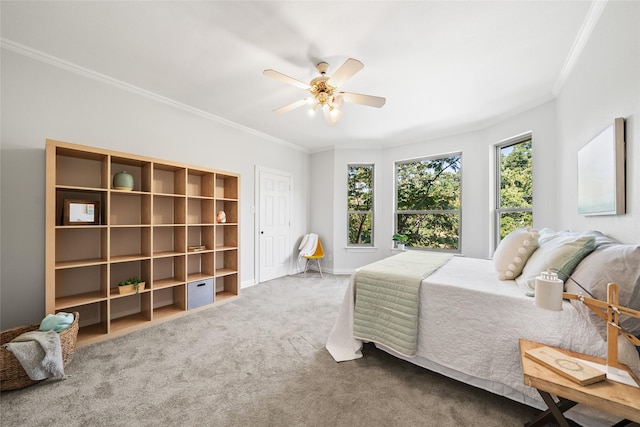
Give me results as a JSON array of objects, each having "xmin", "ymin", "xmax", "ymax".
[{"xmin": 496, "ymin": 134, "xmax": 533, "ymax": 247}]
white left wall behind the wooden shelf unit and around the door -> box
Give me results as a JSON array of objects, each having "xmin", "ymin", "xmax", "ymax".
[{"xmin": 0, "ymin": 49, "xmax": 309, "ymax": 329}]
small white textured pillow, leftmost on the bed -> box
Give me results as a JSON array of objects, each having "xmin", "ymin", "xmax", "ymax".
[{"xmin": 493, "ymin": 227, "xmax": 539, "ymax": 280}]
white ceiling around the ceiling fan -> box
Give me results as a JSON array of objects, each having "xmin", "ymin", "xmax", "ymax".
[{"xmin": 1, "ymin": 0, "xmax": 592, "ymax": 151}]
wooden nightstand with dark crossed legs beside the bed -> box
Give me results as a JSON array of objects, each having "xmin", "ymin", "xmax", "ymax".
[{"xmin": 520, "ymin": 338, "xmax": 640, "ymax": 427}]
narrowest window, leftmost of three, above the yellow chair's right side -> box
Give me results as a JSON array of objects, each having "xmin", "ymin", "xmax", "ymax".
[{"xmin": 347, "ymin": 165, "xmax": 373, "ymax": 246}]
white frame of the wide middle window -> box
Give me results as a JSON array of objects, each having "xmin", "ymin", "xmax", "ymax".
[{"xmin": 393, "ymin": 151, "xmax": 463, "ymax": 254}]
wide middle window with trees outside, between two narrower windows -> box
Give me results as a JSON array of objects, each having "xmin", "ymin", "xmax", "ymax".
[{"xmin": 395, "ymin": 153, "xmax": 462, "ymax": 251}]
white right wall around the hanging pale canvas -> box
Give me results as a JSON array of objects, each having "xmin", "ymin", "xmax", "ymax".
[{"xmin": 557, "ymin": 1, "xmax": 640, "ymax": 243}]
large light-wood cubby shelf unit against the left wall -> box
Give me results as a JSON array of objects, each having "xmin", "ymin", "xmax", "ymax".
[{"xmin": 45, "ymin": 140, "xmax": 240, "ymax": 346}]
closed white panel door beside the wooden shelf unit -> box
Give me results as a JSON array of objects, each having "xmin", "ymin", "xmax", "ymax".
[{"xmin": 258, "ymin": 169, "xmax": 293, "ymax": 282}]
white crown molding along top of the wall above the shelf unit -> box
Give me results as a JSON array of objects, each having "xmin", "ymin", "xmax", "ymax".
[{"xmin": 0, "ymin": 37, "xmax": 309, "ymax": 153}]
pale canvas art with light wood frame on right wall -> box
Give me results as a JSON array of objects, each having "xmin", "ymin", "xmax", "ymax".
[{"xmin": 578, "ymin": 118, "xmax": 625, "ymax": 215}]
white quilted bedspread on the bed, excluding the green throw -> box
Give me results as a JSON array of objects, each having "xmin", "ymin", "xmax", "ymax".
[{"xmin": 326, "ymin": 257, "xmax": 640, "ymax": 426}]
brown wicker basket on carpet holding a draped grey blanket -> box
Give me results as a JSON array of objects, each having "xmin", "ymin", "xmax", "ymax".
[{"xmin": 0, "ymin": 312, "xmax": 80, "ymax": 391}]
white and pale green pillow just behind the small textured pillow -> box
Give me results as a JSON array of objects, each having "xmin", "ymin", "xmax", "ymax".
[{"xmin": 516, "ymin": 233, "xmax": 596, "ymax": 289}]
